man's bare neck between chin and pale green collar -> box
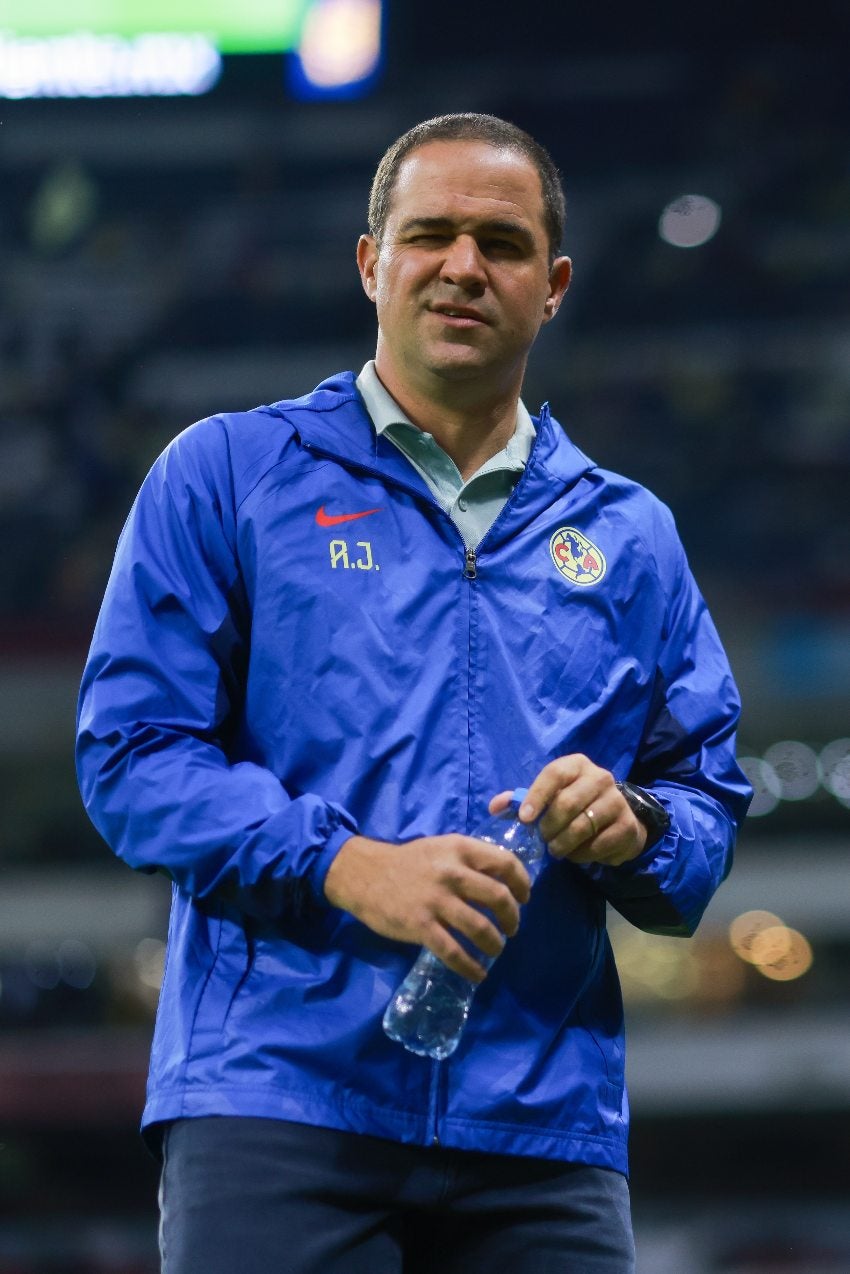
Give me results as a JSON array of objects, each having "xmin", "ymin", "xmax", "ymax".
[{"xmin": 375, "ymin": 359, "xmax": 520, "ymax": 479}]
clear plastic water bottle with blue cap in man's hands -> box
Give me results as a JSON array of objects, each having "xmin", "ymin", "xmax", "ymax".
[{"xmin": 384, "ymin": 787, "xmax": 545, "ymax": 1059}]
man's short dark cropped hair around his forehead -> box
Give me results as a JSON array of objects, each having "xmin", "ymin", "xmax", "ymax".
[{"xmin": 368, "ymin": 111, "xmax": 566, "ymax": 257}]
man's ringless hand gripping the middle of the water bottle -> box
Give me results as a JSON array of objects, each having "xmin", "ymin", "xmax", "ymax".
[{"xmin": 325, "ymin": 834, "xmax": 531, "ymax": 982}]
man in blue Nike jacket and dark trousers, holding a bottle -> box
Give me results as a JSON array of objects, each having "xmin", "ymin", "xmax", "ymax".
[{"xmin": 79, "ymin": 115, "xmax": 748, "ymax": 1274}]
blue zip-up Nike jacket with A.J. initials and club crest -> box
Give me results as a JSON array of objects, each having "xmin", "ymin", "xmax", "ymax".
[{"xmin": 78, "ymin": 373, "xmax": 749, "ymax": 1172}]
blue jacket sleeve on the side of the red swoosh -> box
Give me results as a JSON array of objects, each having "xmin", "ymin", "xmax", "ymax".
[{"xmin": 76, "ymin": 419, "xmax": 357, "ymax": 917}]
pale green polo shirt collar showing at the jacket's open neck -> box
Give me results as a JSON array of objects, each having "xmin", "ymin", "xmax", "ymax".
[{"xmin": 357, "ymin": 361, "xmax": 537, "ymax": 549}]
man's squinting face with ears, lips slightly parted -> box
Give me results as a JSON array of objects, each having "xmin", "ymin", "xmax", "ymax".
[{"xmin": 358, "ymin": 141, "xmax": 570, "ymax": 394}]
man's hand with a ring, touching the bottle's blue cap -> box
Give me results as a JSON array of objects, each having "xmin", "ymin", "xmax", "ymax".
[{"xmin": 489, "ymin": 753, "xmax": 646, "ymax": 866}]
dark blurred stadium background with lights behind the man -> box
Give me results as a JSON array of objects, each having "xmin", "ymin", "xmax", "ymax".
[{"xmin": 0, "ymin": 0, "xmax": 850, "ymax": 1274}]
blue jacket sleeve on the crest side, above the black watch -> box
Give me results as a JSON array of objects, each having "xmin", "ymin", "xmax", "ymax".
[{"xmin": 587, "ymin": 506, "xmax": 752, "ymax": 936}]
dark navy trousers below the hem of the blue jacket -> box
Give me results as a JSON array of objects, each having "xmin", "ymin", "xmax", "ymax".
[{"xmin": 159, "ymin": 1116, "xmax": 635, "ymax": 1274}]
